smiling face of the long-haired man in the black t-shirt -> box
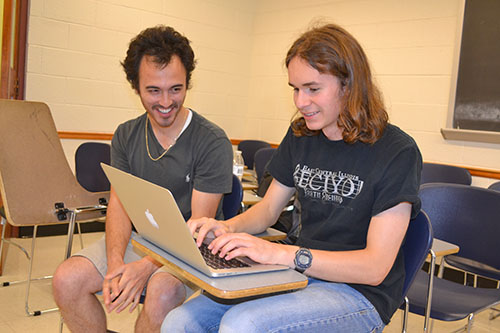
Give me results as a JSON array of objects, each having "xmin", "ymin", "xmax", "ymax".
[{"xmin": 288, "ymin": 56, "xmax": 343, "ymax": 140}]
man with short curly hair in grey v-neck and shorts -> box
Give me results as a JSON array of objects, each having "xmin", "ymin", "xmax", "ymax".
[{"xmin": 53, "ymin": 26, "xmax": 232, "ymax": 332}]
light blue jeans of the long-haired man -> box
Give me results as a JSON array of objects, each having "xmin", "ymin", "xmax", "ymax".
[{"xmin": 161, "ymin": 278, "xmax": 384, "ymax": 333}]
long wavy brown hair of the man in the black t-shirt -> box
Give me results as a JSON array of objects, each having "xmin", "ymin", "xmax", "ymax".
[{"xmin": 285, "ymin": 24, "xmax": 389, "ymax": 143}]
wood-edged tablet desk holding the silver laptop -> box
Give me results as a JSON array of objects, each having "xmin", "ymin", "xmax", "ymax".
[{"xmin": 132, "ymin": 235, "xmax": 307, "ymax": 301}]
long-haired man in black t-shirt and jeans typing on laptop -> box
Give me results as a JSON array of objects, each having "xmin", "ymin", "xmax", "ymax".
[{"xmin": 162, "ymin": 24, "xmax": 422, "ymax": 332}]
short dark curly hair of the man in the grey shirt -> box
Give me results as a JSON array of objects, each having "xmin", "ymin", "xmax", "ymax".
[{"xmin": 121, "ymin": 25, "xmax": 196, "ymax": 93}]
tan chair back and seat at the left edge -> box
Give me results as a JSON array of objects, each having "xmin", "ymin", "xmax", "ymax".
[{"xmin": 0, "ymin": 100, "xmax": 106, "ymax": 226}]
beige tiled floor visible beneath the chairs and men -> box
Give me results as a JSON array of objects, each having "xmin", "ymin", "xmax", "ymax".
[{"xmin": 0, "ymin": 232, "xmax": 500, "ymax": 333}]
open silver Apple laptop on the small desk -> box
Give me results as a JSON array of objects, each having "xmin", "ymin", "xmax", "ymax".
[{"xmin": 101, "ymin": 163, "xmax": 288, "ymax": 277}]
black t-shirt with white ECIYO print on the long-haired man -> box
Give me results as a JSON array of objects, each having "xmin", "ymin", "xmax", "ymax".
[{"xmin": 268, "ymin": 125, "xmax": 422, "ymax": 324}]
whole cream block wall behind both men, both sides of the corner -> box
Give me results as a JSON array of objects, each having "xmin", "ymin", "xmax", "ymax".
[{"xmin": 27, "ymin": 0, "xmax": 500, "ymax": 176}]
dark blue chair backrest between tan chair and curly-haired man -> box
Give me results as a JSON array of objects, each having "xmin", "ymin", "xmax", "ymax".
[{"xmin": 75, "ymin": 142, "xmax": 111, "ymax": 192}]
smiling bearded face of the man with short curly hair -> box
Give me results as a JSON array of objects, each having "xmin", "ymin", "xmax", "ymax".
[{"xmin": 139, "ymin": 55, "xmax": 187, "ymax": 131}]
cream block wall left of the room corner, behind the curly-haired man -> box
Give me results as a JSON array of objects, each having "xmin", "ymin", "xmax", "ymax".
[{"xmin": 26, "ymin": 0, "xmax": 255, "ymax": 169}]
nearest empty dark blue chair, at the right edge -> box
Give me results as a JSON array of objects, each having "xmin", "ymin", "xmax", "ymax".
[{"xmin": 408, "ymin": 183, "xmax": 500, "ymax": 330}]
